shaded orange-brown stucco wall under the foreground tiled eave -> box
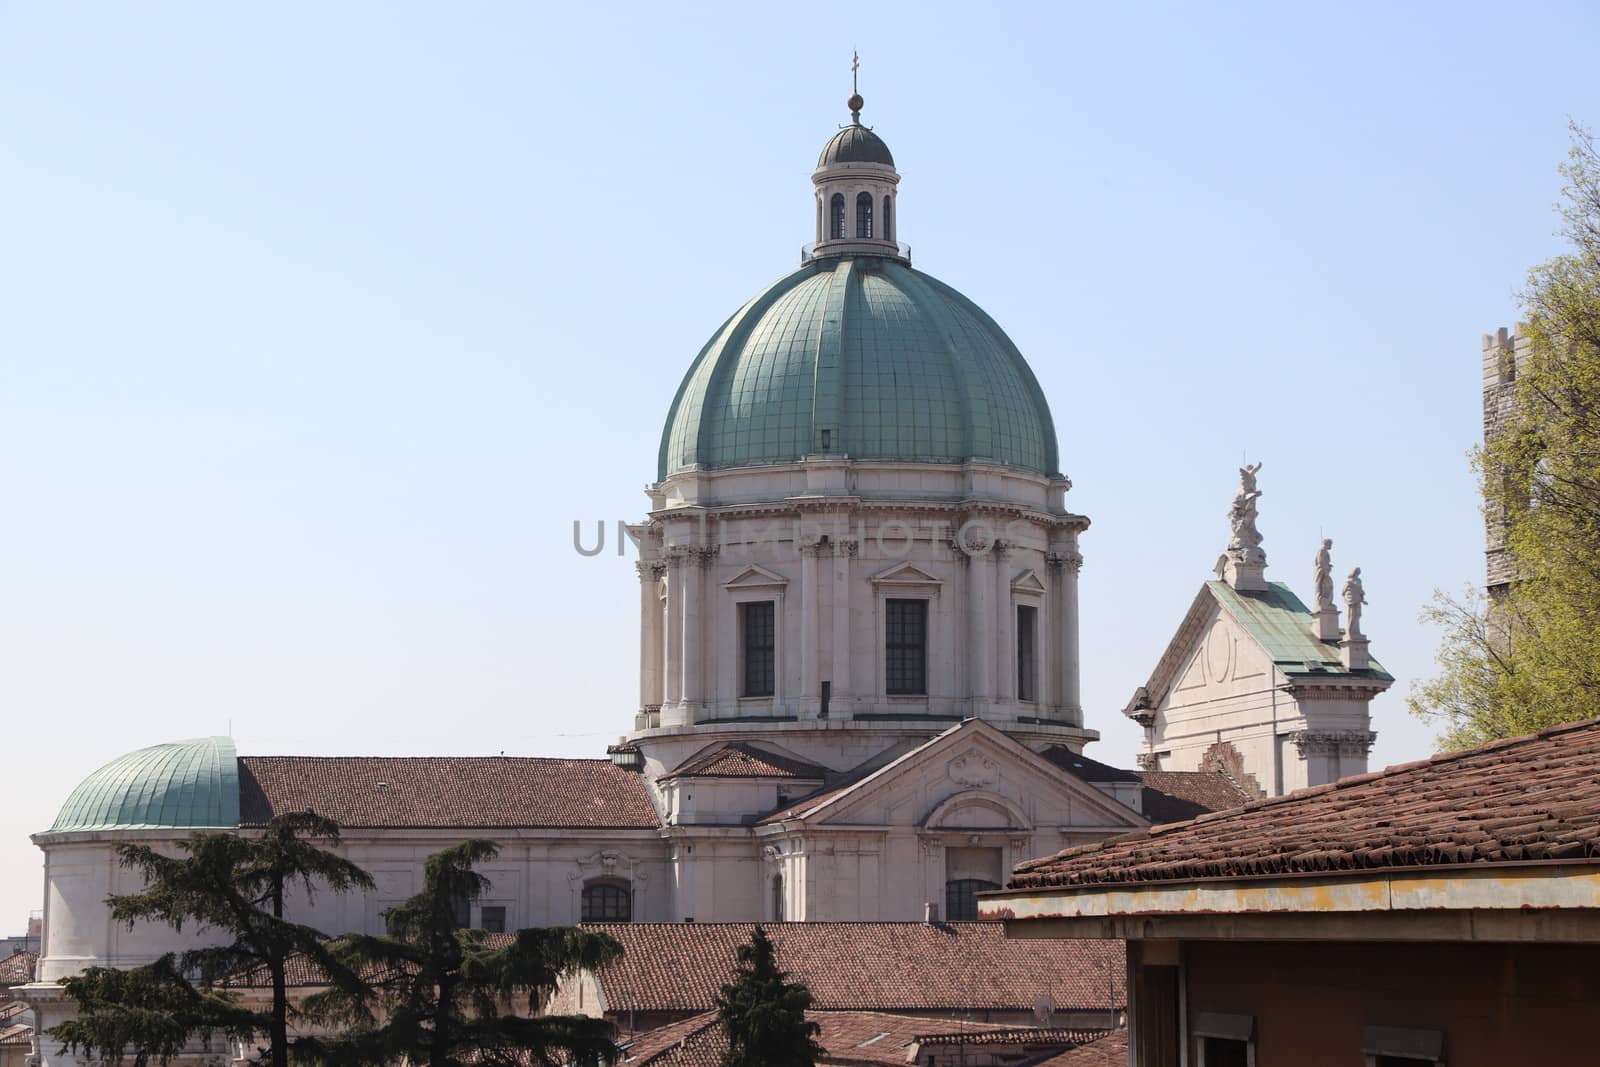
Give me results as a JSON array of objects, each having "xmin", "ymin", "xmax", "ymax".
[{"xmin": 1181, "ymin": 941, "xmax": 1600, "ymax": 1067}]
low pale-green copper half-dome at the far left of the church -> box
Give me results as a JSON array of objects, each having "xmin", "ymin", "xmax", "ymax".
[{"xmin": 50, "ymin": 737, "xmax": 238, "ymax": 833}]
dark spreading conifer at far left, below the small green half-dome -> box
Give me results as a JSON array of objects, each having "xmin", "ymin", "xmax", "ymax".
[{"xmin": 50, "ymin": 811, "xmax": 373, "ymax": 1067}]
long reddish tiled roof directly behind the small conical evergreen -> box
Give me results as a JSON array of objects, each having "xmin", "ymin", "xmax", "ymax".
[{"xmin": 584, "ymin": 923, "xmax": 1123, "ymax": 1016}]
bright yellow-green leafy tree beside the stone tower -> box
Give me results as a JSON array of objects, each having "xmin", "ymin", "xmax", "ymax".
[{"xmin": 1408, "ymin": 125, "xmax": 1600, "ymax": 745}]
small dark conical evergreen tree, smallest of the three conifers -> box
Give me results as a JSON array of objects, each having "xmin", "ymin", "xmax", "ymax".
[{"xmin": 717, "ymin": 926, "xmax": 824, "ymax": 1067}]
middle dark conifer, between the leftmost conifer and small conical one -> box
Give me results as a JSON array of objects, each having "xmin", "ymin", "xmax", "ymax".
[{"xmin": 296, "ymin": 840, "xmax": 622, "ymax": 1067}]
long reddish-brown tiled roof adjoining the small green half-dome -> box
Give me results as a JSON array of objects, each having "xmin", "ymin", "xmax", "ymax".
[{"xmin": 238, "ymin": 755, "xmax": 659, "ymax": 829}]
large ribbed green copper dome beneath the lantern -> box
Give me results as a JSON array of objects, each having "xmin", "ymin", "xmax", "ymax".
[{"xmin": 659, "ymin": 256, "xmax": 1059, "ymax": 478}]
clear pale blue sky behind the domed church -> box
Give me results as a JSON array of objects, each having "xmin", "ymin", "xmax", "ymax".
[{"xmin": 0, "ymin": 0, "xmax": 1600, "ymax": 933}]
